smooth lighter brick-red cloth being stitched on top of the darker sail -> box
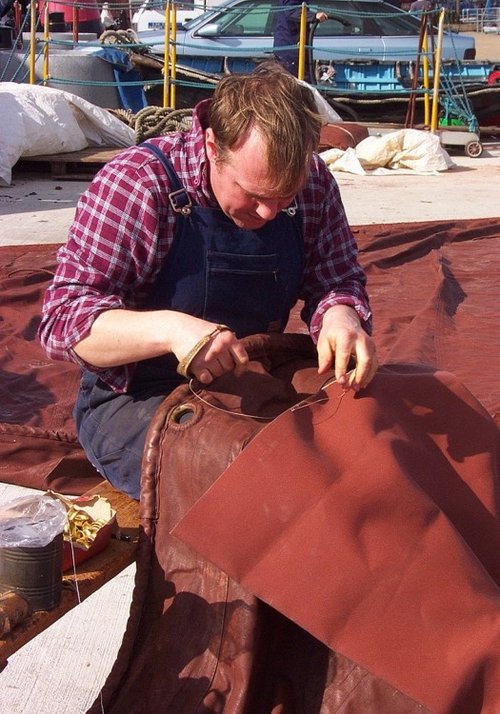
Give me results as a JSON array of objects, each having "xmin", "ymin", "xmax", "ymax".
[{"xmin": 173, "ymin": 365, "xmax": 500, "ymax": 714}]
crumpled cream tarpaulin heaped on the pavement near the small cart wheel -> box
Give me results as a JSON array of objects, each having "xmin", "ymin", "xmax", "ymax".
[{"xmin": 321, "ymin": 129, "xmax": 455, "ymax": 175}]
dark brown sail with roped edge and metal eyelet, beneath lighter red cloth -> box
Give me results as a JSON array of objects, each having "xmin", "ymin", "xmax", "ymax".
[{"xmin": 89, "ymin": 334, "xmax": 428, "ymax": 714}]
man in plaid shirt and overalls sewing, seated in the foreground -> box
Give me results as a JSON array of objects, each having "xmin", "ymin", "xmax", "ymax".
[{"xmin": 39, "ymin": 63, "xmax": 377, "ymax": 498}]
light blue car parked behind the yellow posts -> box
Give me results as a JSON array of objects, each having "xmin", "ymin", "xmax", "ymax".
[{"xmin": 137, "ymin": 0, "xmax": 476, "ymax": 74}]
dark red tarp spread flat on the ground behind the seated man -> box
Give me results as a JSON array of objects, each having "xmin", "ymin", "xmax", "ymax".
[{"xmin": 0, "ymin": 219, "xmax": 500, "ymax": 482}]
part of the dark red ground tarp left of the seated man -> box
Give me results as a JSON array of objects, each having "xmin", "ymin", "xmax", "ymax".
[{"xmin": 0, "ymin": 245, "xmax": 101, "ymax": 494}]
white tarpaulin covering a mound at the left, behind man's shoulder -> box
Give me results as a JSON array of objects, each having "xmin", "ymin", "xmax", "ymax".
[{"xmin": 0, "ymin": 82, "xmax": 135, "ymax": 186}]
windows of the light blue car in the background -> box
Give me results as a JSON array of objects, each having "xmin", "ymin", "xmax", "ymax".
[{"xmin": 184, "ymin": 0, "xmax": 420, "ymax": 37}]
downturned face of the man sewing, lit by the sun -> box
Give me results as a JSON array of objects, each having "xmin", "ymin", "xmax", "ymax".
[{"xmin": 205, "ymin": 128, "xmax": 302, "ymax": 230}]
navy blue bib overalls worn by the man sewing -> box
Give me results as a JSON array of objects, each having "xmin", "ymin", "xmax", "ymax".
[{"xmin": 75, "ymin": 144, "xmax": 304, "ymax": 499}]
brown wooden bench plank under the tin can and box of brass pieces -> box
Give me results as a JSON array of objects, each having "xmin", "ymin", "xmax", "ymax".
[{"xmin": 0, "ymin": 482, "xmax": 139, "ymax": 660}]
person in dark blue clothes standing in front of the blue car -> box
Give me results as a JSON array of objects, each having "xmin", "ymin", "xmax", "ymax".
[{"xmin": 273, "ymin": 0, "xmax": 328, "ymax": 81}]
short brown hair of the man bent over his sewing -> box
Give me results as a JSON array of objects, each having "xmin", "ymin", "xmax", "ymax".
[{"xmin": 208, "ymin": 62, "xmax": 322, "ymax": 194}]
